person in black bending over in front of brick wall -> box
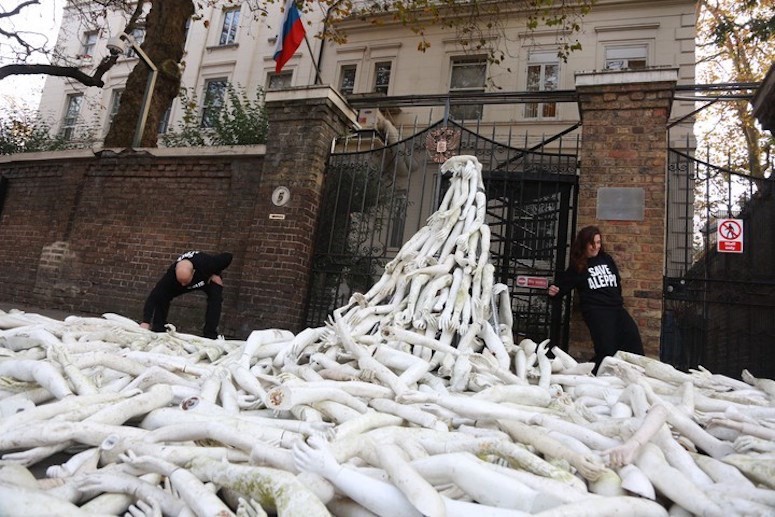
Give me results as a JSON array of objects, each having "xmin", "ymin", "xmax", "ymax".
[{"xmin": 140, "ymin": 251, "xmax": 232, "ymax": 339}]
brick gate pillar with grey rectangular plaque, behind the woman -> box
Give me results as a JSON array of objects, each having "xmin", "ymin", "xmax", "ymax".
[{"xmin": 571, "ymin": 68, "xmax": 678, "ymax": 357}]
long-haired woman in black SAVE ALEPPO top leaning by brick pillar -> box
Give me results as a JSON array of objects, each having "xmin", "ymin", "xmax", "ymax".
[{"xmin": 548, "ymin": 226, "xmax": 643, "ymax": 373}]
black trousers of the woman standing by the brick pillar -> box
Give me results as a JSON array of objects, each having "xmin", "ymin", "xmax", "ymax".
[{"xmin": 582, "ymin": 307, "xmax": 643, "ymax": 373}]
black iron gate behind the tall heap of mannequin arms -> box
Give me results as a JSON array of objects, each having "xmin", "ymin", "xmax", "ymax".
[{"xmin": 306, "ymin": 121, "xmax": 578, "ymax": 349}]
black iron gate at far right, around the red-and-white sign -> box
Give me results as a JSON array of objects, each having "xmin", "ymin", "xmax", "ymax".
[{"xmin": 661, "ymin": 149, "xmax": 775, "ymax": 378}]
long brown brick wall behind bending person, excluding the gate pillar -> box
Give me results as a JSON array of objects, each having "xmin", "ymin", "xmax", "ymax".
[{"xmin": 0, "ymin": 146, "xmax": 264, "ymax": 332}]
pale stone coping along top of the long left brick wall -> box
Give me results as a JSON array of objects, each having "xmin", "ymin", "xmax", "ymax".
[{"xmin": 0, "ymin": 144, "xmax": 266, "ymax": 164}]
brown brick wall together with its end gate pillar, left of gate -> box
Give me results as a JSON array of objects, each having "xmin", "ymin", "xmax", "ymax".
[{"xmin": 0, "ymin": 87, "xmax": 355, "ymax": 338}]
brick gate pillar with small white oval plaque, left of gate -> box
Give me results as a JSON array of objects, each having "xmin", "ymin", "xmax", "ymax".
[{"xmin": 235, "ymin": 86, "xmax": 356, "ymax": 335}]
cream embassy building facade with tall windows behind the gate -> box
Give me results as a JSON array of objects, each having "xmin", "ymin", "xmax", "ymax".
[{"xmin": 40, "ymin": 0, "xmax": 696, "ymax": 149}]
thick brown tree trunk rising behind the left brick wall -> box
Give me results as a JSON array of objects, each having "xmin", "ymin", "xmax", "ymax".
[{"xmin": 104, "ymin": 0, "xmax": 194, "ymax": 147}]
